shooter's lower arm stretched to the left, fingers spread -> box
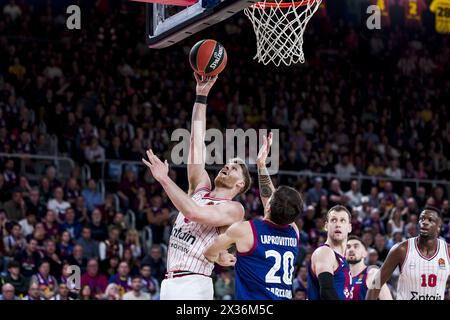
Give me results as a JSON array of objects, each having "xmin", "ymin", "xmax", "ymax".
[{"xmin": 142, "ymin": 150, "xmax": 244, "ymax": 227}]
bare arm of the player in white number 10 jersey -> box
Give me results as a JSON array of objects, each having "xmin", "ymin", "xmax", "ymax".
[{"xmin": 366, "ymin": 242, "xmax": 406, "ymax": 300}]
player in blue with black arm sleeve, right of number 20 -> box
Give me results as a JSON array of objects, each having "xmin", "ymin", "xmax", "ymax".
[{"xmin": 308, "ymin": 205, "xmax": 352, "ymax": 300}]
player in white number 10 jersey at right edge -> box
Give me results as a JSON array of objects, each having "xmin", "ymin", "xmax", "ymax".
[{"xmin": 367, "ymin": 207, "xmax": 450, "ymax": 300}]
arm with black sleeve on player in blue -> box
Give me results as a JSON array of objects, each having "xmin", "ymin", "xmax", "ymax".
[{"xmin": 311, "ymin": 246, "xmax": 339, "ymax": 300}]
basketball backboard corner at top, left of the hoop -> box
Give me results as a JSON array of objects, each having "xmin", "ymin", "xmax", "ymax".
[{"xmin": 146, "ymin": 0, "xmax": 258, "ymax": 49}]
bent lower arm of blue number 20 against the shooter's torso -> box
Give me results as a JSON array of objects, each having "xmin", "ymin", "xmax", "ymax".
[{"xmin": 203, "ymin": 221, "xmax": 251, "ymax": 266}]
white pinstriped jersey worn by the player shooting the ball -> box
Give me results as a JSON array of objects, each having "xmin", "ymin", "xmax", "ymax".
[{"xmin": 167, "ymin": 188, "xmax": 230, "ymax": 276}]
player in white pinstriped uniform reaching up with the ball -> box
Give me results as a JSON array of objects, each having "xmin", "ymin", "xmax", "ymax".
[{"xmin": 142, "ymin": 74, "xmax": 251, "ymax": 300}]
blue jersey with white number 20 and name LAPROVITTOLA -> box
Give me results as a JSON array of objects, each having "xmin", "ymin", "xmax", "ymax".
[{"xmin": 234, "ymin": 220, "xmax": 298, "ymax": 300}]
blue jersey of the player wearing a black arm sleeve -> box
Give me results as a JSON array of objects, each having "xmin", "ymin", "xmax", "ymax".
[{"xmin": 307, "ymin": 244, "xmax": 352, "ymax": 300}]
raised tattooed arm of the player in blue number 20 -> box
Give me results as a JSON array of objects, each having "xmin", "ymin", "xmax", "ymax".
[{"xmin": 256, "ymin": 133, "xmax": 275, "ymax": 208}]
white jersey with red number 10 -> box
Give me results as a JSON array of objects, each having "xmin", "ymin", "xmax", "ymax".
[{"xmin": 397, "ymin": 237, "xmax": 450, "ymax": 300}]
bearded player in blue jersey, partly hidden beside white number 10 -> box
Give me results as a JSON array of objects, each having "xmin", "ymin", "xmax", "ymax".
[{"xmin": 345, "ymin": 236, "xmax": 392, "ymax": 300}]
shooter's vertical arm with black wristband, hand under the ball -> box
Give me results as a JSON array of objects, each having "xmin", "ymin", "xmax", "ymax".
[{"xmin": 187, "ymin": 73, "xmax": 217, "ymax": 195}]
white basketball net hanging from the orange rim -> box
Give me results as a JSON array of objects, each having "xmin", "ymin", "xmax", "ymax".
[{"xmin": 244, "ymin": 0, "xmax": 322, "ymax": 66}]
